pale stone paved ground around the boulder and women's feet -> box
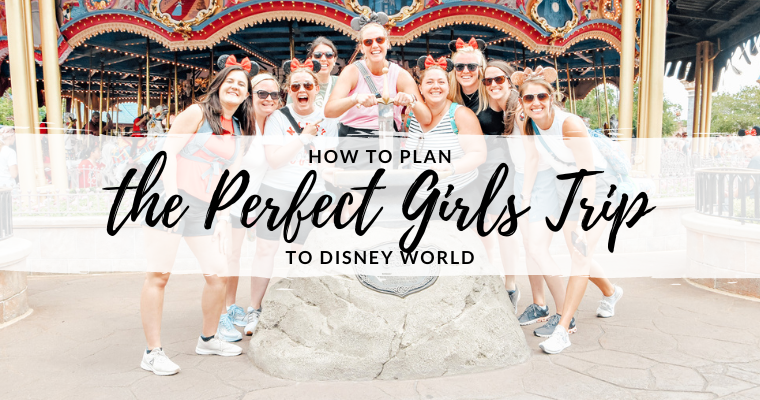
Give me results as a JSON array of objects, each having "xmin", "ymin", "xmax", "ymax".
[{"xmin": 0, "ymin": 274, "xmax": 760, "ymax": 400}]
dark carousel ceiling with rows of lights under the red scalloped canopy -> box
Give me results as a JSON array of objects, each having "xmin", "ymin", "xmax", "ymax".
[{"xmin": 53, "ymin": 21, "xmax": 620, "ymax": 104}]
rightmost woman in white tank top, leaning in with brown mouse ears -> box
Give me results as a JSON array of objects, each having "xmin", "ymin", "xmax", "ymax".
[{"xmin": 512, "ymin": 67, "xmax": 623, "ymax": 354}]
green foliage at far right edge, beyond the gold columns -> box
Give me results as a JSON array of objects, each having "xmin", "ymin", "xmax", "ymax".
[{"xmin": 710, "ymin": 85, "xmax": 760, "ymax": 133}]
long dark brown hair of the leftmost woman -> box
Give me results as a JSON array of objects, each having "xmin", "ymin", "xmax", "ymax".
[{"xmin": 198, "ymin": 65, "xmax": 256, "ymax": 136}]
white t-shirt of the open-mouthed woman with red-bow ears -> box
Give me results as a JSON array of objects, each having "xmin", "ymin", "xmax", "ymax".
[{"xmin": 263, "ymin": 105, "xmax": 338, "ymax": 193}]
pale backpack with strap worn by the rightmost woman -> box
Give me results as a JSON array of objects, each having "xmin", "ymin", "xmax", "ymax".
[{"xmin": 531, "ymin": 120, "xmax": 639, "ymax": 202}]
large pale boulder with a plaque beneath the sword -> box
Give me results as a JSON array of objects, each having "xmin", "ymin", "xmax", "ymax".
[{"xmin": 248, "ymin": 224, "xmax": 530, "ymax": 381}]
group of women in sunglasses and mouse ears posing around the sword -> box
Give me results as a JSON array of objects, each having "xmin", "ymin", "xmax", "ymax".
[{"xmin": 141, "ymin": 16, "xmax": 622, "ymax": 375}]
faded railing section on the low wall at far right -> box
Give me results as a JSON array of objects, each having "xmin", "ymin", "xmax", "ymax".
[{"xmin": 695, "ymin": 168, "xmax": 760, "ymax": 224}]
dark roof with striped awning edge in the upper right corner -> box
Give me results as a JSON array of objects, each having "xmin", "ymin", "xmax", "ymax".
[{"xmin": 665, "ymin": 0, "xmax": 760, "ymax": 89}]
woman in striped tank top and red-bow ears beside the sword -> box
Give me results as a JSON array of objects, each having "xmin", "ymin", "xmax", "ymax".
[{"xmin": 406, "ymin": 56, "xmax": 486, "ymax": 204}]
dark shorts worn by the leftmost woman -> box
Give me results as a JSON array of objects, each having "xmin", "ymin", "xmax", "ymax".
[{"xmin": 139, "ymin": 188, "xmax": 217, "ymax": 237}]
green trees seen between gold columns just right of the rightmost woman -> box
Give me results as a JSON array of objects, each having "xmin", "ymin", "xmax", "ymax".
[{"xmin": 568, "ymin": 83, "xmax": 683, "ymax": 136}]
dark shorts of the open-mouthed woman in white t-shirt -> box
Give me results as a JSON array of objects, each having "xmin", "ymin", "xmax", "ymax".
[{"xmin": 255, "ymin": 185, "xmax": 323, "ymax": 244}]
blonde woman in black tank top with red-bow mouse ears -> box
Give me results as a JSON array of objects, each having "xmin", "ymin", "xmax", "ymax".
[{"xmin": 449, "ymin": 39, "xmax": 520, "ymax": 313}]
